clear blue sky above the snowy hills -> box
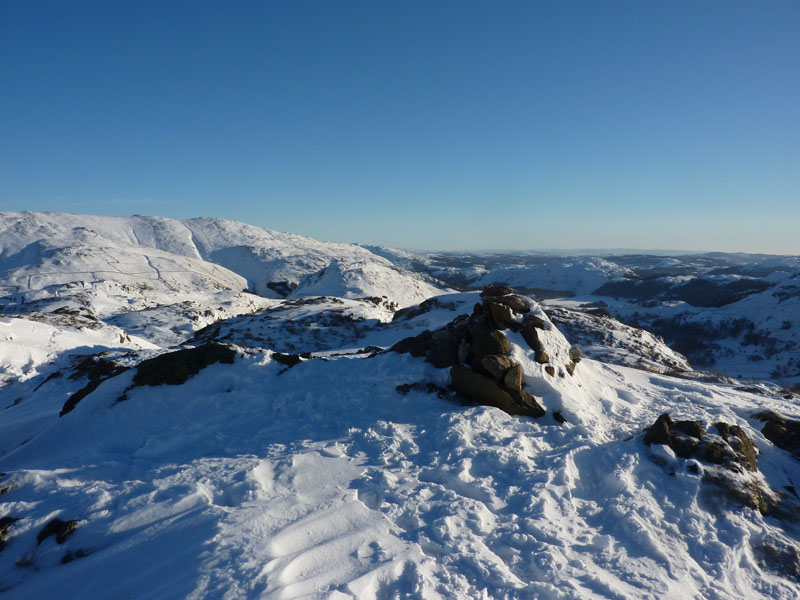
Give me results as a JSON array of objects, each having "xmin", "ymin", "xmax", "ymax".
[{"xmin": 0, "ymin": 0, "xmax": 800, "ymax": 253}]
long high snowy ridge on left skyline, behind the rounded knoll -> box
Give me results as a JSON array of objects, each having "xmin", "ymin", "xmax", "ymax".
[{"xmin": 0, "ymin": 213, "xmax": 441, "ymax": 298}]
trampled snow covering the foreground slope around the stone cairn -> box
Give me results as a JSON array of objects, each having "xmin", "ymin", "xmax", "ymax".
[{"xmin": 0, "ymin": 293, "xmax": 800, "ymax": 599}]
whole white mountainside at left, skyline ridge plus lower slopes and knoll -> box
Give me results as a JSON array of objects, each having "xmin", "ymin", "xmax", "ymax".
[{"xmin": 0, "ymin": 213, "xmax": 442, "ymax": 354}]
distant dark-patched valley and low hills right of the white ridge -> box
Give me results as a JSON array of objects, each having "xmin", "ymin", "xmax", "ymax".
[{"xmin": 375, "ymin": 247, "xmax": 800, "ymax": 389}]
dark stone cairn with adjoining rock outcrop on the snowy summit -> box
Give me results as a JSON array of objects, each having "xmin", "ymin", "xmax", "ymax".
[{"xmin": 391, "ymin": 286, "xmax": 580, "ymax": 418}]
